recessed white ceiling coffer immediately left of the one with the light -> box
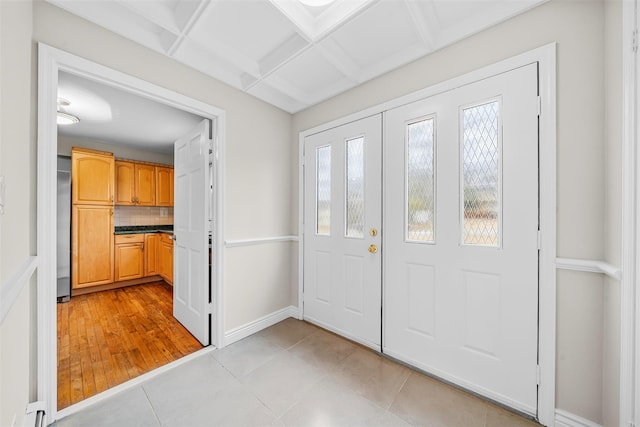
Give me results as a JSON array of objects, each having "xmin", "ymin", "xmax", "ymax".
[{"xmin": 188, "ymin": 1, "xmax": 302, "ymax": 67}]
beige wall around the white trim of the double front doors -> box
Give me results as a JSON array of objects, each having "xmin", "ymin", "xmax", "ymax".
[{"xmin": 291, "ymin": 0, "xmax": 605, "ymax": 423}]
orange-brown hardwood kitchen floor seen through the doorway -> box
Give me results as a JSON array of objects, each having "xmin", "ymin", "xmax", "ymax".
[{"xmin": 57, "ymin": 282, "xmax": 202, "ymax": 409}]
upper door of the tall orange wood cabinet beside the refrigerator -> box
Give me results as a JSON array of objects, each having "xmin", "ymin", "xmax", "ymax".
[{"xmin": 71, "ymin": 147, "xmax": 115, "ymax": 205}]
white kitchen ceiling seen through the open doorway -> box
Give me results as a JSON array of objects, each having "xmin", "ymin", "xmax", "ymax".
[{"xmin": 58, "ymin": 71, "xmax": 202, "ymax": 153}]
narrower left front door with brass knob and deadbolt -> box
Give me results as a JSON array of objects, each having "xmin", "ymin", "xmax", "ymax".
[{"xmin": 303, "ymin": 115, "xmax": 382, "ymax": 349}]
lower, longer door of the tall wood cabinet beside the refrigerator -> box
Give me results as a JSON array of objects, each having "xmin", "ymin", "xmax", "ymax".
[{"xmin": 71, "ymin": 205, "xmax": 114, "ymax": 288}]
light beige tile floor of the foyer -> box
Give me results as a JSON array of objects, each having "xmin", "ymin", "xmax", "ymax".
[{"xmin": 51, "ymin": 319, "xmax": 538, "ymax": 427}]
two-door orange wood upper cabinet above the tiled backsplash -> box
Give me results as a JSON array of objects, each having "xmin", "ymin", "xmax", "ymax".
[{"xmin": 115, "ymin": 160, "xmax": 156, "ymax": 206}]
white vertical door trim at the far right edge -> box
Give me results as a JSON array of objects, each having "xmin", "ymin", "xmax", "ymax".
[{"xmin": 619, "ymin": 1, "xmax": 640, "ymax": 426}]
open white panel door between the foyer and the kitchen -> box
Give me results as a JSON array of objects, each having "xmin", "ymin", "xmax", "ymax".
[{"xmin": 173, "ymin": 120, "xmax": 211, "ymax": 345}]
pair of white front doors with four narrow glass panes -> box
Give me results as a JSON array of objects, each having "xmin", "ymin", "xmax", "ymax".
[{"xmin": 303, "ymin": 64, "xmax": 538, "ymax": 415}]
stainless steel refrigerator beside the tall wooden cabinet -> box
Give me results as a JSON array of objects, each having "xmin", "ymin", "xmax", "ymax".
[{"xmin": 56, "ymin": 156, "xmax": 71, "ymax": 302}]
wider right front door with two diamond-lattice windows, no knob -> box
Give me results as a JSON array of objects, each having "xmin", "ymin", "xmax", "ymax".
[{"xmin": 383, "ymin": 64, "xmax": 538, "ymax": 415}]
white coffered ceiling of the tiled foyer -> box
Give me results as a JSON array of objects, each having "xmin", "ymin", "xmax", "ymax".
[{"xmin": 47, "ymin": 0, "xmax": 546, "ymax": 113}]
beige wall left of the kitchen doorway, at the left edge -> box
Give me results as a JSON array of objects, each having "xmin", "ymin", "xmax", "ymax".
[{"xmin": 0, "ymin": 1, "xmax": 36, "ymax": 426}]
